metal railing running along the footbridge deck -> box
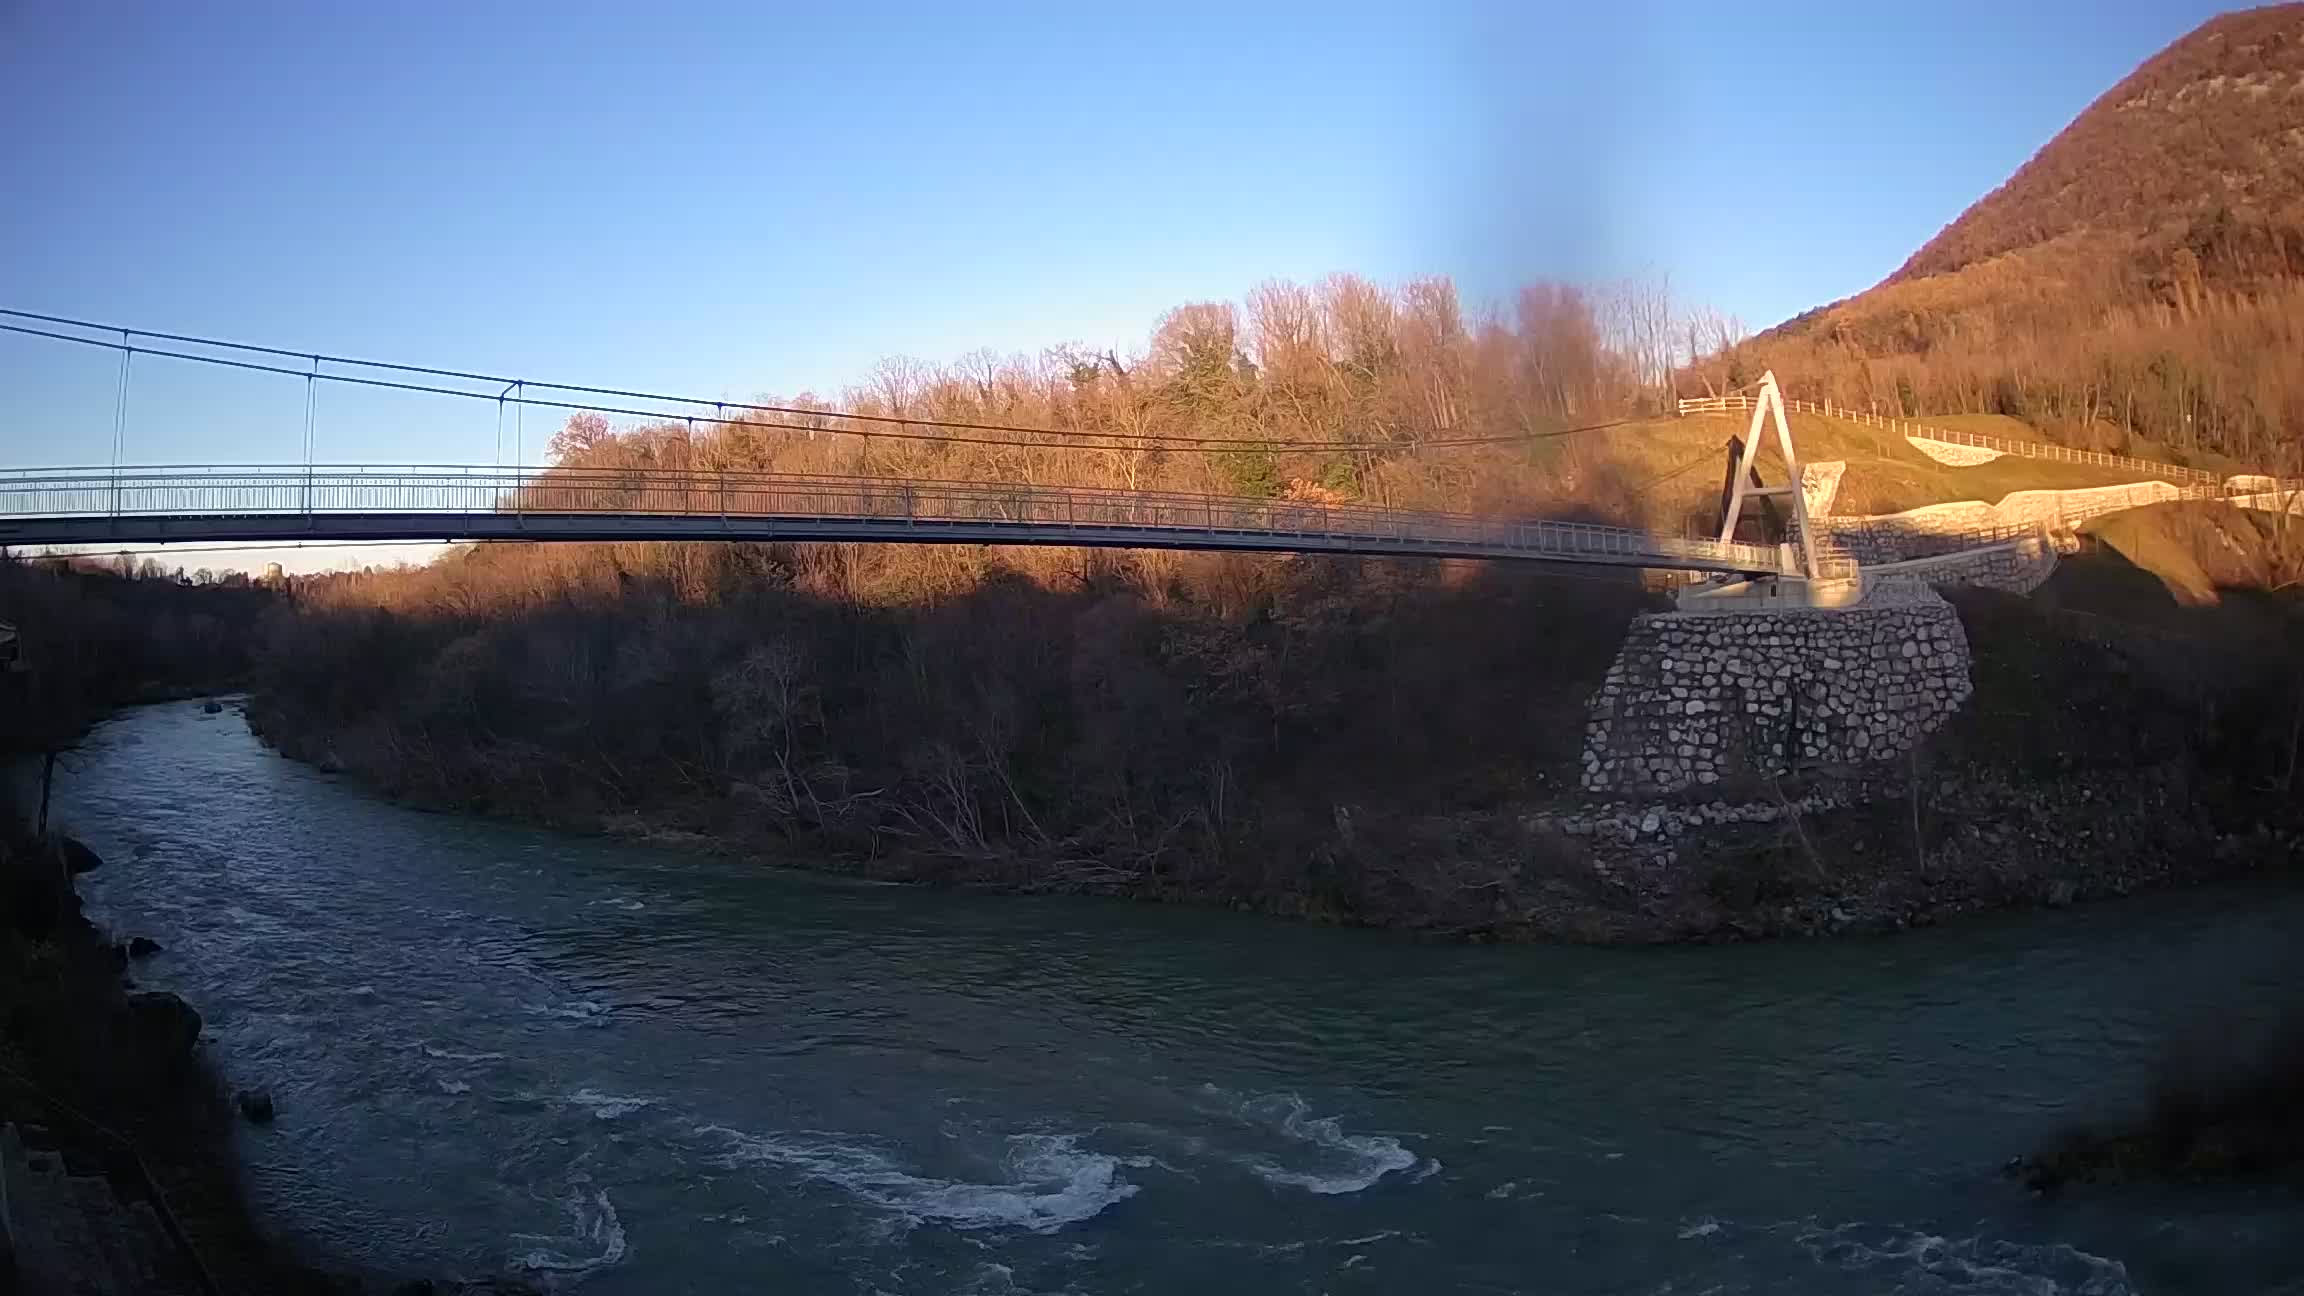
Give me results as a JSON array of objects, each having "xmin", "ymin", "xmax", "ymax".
[{"xmin": 0, "ymin": 466, "xmax": 1788, "ymax": 572}]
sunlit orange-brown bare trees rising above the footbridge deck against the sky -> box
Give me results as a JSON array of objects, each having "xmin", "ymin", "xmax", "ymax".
[{"xmin": 513, "ymin": 274, "xmax": 1687, "ymax": 512}]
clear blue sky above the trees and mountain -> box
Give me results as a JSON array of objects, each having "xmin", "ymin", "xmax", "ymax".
[{"xmin": 0, "ymin": 0, "xmax": 2219, "ymax": 562}]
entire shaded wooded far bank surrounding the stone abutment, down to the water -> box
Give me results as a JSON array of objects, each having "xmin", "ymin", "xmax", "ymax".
[{"xmin": 253, "ymin": 525, "xmax": 2304, "ymax": 941}]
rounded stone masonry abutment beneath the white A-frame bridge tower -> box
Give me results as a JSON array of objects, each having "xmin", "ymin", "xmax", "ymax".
[{"xmin": 1583, "ymin": 586, "xmax": 1970, "ymax": 796}]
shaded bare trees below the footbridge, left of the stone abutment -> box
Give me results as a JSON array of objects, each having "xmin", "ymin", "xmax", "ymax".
[{"xmin": 253, "ymin": 544, "xmax": 1650, "ymax": 920}]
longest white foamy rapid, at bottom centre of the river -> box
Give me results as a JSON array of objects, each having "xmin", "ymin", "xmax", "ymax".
[{"xmin": 698, "ymin": 1125, "xmax": 1136, "ymax": 1234}]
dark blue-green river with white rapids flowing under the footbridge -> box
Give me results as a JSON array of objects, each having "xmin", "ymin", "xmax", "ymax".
[{"xmin": 31, "ymin": 703, "xmax": 2304, "ymax": 1296}]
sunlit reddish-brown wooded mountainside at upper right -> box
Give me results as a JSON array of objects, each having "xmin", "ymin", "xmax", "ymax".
[{"xmin": 1687, "ymin": 5, "xmax": 2304, "ymax": 473}]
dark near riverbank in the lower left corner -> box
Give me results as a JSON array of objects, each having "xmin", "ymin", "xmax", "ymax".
[{"xmin": 0, "ymin": 826, "xmax": 535, "ymax": 1296}]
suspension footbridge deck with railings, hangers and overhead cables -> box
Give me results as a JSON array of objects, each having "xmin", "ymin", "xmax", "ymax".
[{"xmin": 0, "ymin": 309, "xmax": 1813, "ymax": 577}]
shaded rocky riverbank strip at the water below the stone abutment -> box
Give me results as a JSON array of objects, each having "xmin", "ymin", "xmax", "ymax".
[{"xmin": 1491, "ymin": 766, "xmax": 2304, "ymax": 943}]
